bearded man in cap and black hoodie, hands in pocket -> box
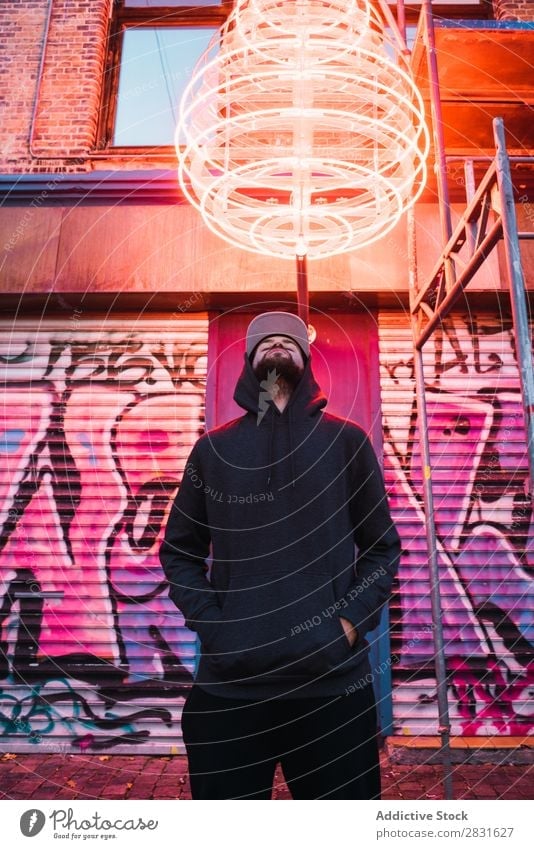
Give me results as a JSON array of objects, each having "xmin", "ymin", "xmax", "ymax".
[{"xmin": 160, "ymin": 312, "xmax": 400, "ymax": 799}]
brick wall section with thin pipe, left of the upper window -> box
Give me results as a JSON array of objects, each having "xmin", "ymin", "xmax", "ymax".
[{"xmin": 0, "ymin": 0, "xmax": 112, "ymax": 173}]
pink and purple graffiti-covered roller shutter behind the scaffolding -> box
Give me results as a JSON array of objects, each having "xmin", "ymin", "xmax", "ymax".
[{"xmin": 379, "ymin": 312, "xmax": 534, "ymax": 736}]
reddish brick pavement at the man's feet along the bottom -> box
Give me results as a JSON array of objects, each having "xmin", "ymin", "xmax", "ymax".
[{"xmin": 0, "ymin": 752, "xmax": 534, "ymax": 800}]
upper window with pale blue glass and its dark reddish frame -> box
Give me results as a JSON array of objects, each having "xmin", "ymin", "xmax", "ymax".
[{"xmin": 99, "ymin": 0, "xmax": 233, "ymax": 148}]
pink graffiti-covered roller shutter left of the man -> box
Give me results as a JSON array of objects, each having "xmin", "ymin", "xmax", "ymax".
[{"xmin": 0, "ymin": 310, "xmax": 208, "ymax": 753}]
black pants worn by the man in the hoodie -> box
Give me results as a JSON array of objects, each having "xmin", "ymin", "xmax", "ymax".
[{"xmin": 182, "ymin": 684, "xmax": 380, "ymax": 799}]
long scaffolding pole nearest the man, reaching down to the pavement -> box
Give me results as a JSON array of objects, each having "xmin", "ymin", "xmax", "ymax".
[{"xmin": 408, "ymin": 209, "xmax": 454, "ymax": 799}]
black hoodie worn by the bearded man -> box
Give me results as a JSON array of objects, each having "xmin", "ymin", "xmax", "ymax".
[{"xmin": 160, "ymin": 356, "xmax": 400, "ymax": 699}]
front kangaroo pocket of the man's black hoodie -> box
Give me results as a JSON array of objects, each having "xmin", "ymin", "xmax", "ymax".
[{"xmin": 207, "ymin": 571, "xmax": 353, "ymax": 680}]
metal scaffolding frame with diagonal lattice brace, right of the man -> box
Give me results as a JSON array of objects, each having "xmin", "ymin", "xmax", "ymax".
[{"xmin": 409, "ymin": 9, "xmax": 534, "ymax": 798}]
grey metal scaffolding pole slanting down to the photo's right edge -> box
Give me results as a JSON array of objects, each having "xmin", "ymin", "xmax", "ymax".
[{"xmin": 493, "ymin": 118, "xmax": 534, "ymax": 498}]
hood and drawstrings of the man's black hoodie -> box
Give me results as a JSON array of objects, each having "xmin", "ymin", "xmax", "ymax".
[{"xmin": 234, "ymin": 354, "xmax": 328, "ymax": 488}]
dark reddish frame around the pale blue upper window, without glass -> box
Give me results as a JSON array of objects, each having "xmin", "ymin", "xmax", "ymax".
[{"xmin": 96, "ymin": 0, "xmax": 234, "ymax": 155}]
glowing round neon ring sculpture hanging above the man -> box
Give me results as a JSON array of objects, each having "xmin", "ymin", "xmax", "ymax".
[{"xmin": 176, "ymin": 0, "xmax": 429, "ymax": 259}]
